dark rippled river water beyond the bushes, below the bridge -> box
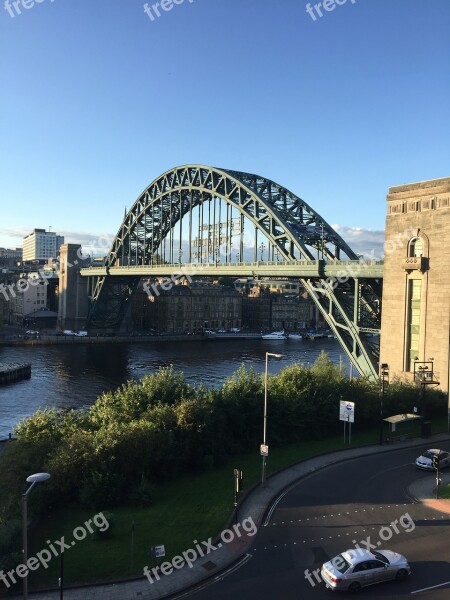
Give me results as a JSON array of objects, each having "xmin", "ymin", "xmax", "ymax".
[{"xmin": 0, "ymin": 338, "xmax": 349, "ymax": 439}]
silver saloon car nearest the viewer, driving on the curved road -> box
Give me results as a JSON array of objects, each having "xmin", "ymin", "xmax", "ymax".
[{"xmin": 320, "ymin": 548, "xmax": 411, "ymax": 592}]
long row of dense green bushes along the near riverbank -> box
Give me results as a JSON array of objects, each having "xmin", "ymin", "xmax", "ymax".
[{"xmin": 0, "ymin": 353, "xmax": 447, "ymax": 522}]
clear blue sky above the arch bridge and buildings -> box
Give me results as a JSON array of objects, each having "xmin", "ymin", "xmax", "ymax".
[{"xmin": 0, "ymin": 0, "xmax": 450, "ymax": 254}]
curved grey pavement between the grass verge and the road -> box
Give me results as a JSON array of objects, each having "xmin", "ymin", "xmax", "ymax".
[{"xmin": 10, "ymin": 434, "xmax": 450, "ymax": 600}]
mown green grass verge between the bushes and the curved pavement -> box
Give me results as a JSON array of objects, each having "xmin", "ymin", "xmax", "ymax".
[{"xmin": 23, "ymin": 419, "xmax": 450, "ymax": 589}]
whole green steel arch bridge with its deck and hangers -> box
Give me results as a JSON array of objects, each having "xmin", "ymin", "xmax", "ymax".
[{"xmin": 81, "ymin": 165, "xmax": 382, "ymax": 378}]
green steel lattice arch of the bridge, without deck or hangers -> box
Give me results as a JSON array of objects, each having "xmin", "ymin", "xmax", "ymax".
[{"xmin": 88, "ymin": 165, "xmax": 381, "ymax": 377}]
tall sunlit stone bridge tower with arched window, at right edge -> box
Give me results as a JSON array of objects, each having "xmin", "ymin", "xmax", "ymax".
[{"xmin": 380, "ymin": 178, "xmax": 450, "ymax": 391}]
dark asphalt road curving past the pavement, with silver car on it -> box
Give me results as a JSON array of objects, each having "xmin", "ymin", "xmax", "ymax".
[{"xmin": 182, "ymin": 442, "xmax": 450, "ymax": 600}]
